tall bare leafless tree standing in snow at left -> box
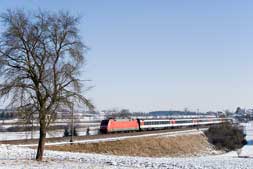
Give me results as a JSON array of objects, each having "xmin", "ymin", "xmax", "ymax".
[{"xmin": 0, "ymin": 10, "xmax": 93, "ymax": 160}]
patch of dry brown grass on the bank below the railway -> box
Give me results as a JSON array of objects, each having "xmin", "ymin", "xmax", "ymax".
[{"xmin": 47, "ymin": 135, "xmax": 210, "ymax": 157}]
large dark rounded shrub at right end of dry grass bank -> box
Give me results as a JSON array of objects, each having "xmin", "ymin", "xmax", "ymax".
[{"xmin": 205, "ymin": 123, "xmax": 247, "ymax": 151}]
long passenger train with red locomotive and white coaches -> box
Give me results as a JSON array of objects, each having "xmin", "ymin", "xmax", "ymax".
[{"xmin": 100, "ymin": 118, "xmax": 232, "ymax": 134}]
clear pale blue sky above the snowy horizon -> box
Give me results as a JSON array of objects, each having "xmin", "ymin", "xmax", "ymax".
[{"xmin": 0, "ymin": 0, "xmax": 253, "ymax": 111}]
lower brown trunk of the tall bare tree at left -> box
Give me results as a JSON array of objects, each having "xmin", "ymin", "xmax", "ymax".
[{"xmin": 36, "ymin": 122, "xmax": 46, "ymax": 161}]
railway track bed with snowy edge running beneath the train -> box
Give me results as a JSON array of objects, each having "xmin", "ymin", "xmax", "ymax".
[{"xmin": 0, "ymin": 127, "xmax": 210, "ymax": 146}]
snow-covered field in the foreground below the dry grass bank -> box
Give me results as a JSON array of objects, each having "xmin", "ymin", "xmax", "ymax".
[{"xmin": 0, "ymin": 123, "xmax": 253, "ymax": 169}]
